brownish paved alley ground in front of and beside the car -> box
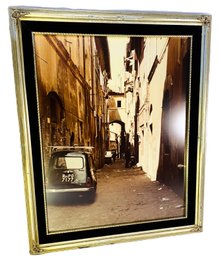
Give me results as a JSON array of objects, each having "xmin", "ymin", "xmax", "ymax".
[{"xmin": 47, "ymin": 160, "xmax": 184, "ymax": 232}]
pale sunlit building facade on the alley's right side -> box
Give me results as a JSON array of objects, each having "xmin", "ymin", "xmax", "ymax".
[{"xmin": 125, "ymin": 37, "xmax": 168, "ymax": 176}]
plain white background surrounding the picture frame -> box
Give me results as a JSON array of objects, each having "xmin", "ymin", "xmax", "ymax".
[{"xmin": 0, "ymin": 0, "xmax": 220, "ymax": 257}]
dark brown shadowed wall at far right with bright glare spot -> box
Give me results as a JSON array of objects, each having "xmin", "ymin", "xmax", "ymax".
[{"xmin": 157, "ymin": 37, "xmax": 191, "ymax": 196}]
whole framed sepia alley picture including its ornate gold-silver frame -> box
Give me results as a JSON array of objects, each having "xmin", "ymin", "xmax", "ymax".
[{"xmin": 9, "ymin": 7, "xmax": 211, "ymax": 254}]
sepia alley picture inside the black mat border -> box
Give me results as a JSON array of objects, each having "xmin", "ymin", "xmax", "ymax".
[{"xmin": 33, "ymin": 33, "xmax": 192, "ymax": 234}]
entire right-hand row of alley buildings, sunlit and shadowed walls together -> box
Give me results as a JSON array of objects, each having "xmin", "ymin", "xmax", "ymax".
[{"xmin": 125, "ymin": 36, "xmax": 190, "ymax": 195}]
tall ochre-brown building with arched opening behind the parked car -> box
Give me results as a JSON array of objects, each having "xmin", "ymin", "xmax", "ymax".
[{"xmin": 34, "ymin": 34, "xmax": 110, "ymax": 166}]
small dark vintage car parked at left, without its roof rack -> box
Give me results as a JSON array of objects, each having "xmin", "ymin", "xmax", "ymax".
[{"xmin": 46, "ymin": 149, "xmax": 97, "ymax": 202}]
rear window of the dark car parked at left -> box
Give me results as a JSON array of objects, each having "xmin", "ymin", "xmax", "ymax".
[{"xmin": 54, "ymin": 156, "xmax": 84, "ymax": 169}]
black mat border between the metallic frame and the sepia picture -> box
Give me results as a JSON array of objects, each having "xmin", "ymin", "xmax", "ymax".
[{"xmin": 21, "ymin": 21, "xmax": 202, "ymax": 244}]
